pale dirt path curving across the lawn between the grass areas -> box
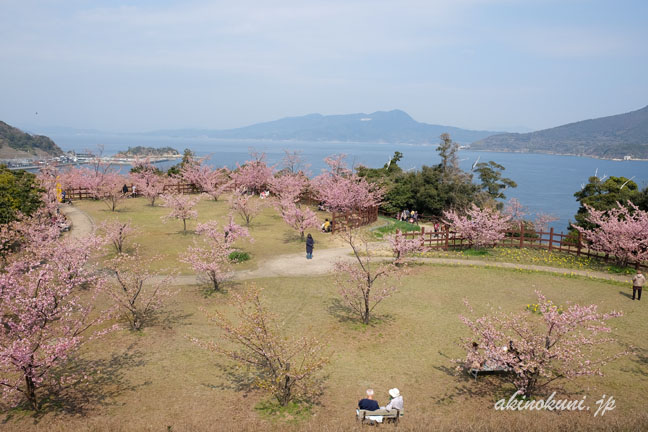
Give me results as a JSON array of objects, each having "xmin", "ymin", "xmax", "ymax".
[{"xmin": 66, "ymin": 205, "xmax": 629, "ymax": 285}]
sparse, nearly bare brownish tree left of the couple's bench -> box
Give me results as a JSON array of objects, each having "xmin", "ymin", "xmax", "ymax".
[{"xmin": 193, "ymin": 288, "xmax": 329, "ymax": 406}]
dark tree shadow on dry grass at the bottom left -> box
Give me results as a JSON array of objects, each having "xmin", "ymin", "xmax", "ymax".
[{"xmin": 0, "ymin": 345, "xmax": 150, "ymax": 424}]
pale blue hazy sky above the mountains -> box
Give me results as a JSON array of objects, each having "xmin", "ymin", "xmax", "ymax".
[{"xmin": 0, "ymin": 0, "xmax": 648, "ymax": 131}]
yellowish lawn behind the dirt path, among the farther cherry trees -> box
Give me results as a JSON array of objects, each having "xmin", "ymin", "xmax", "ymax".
[{"xmin": 74, "ymin": 197, "xmax": 336, "ymax": 274}]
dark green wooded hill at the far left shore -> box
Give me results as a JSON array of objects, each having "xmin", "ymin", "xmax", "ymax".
[{"xmin": 0, "ymin": 121, "xmax": 63, "ymax": 159}]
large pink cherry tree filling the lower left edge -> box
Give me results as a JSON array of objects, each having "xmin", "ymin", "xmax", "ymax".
[{"xmin": 0, "ymin": 228, "xmax": 110, "ymax": 410}]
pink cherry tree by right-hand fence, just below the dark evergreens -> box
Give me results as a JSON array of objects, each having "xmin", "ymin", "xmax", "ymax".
[{"xmin": 443, "ymin": 204, "xmax": 511, "ymax": 248}]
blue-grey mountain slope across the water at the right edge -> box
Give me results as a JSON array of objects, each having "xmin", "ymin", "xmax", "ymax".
[{"xmin": 470, "ymin": 106, "xmax": 648, "ymax": 159}]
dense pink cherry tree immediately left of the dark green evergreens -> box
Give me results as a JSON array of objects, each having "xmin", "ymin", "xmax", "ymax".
[{"xmin": 312, "ymin": 155, "xmax": 385, "ymax": 213}]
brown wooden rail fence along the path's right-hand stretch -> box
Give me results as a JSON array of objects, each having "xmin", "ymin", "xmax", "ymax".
[{"xmin": 403, "ymin": 224, "xmax": 648, "ymax": 268}]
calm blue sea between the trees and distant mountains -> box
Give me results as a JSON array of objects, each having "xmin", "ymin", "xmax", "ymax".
[{"xmin": 50, "ymin": 134, "xmax": 648, "ymax": 231}]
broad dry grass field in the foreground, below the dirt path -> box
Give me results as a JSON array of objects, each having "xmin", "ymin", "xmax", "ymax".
[{"xmin": 5, "ymin": 264, "xmax": 648, "ymax": 431}]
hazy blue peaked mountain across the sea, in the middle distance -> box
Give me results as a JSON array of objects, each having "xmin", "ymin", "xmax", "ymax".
[{"xmin": 147, "ymin": 110, "xmax": 497, "ymax": 144}]
